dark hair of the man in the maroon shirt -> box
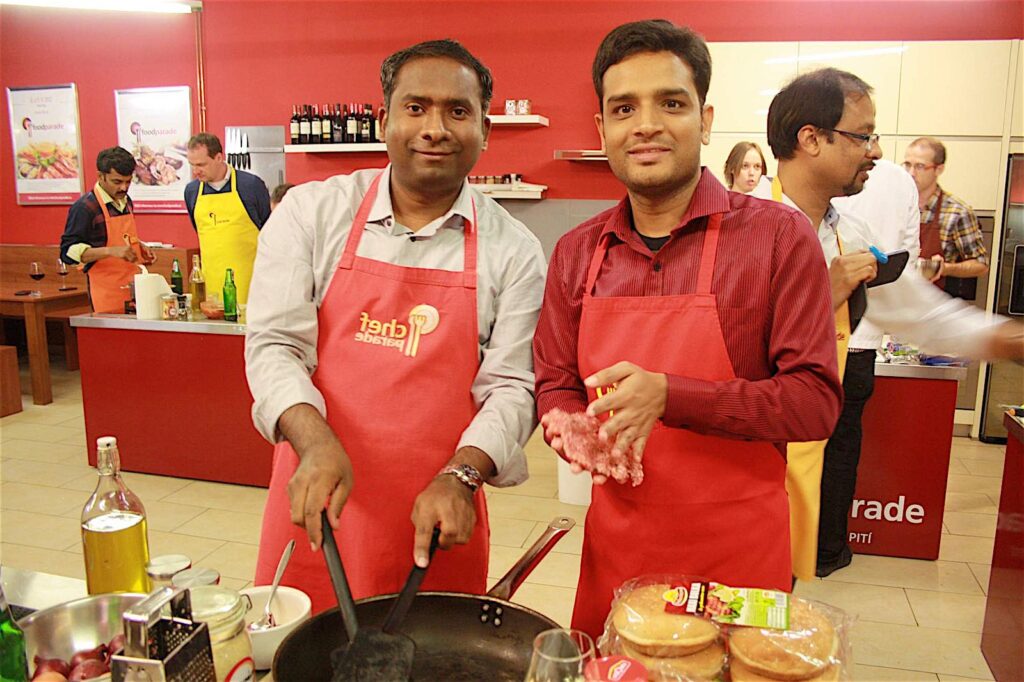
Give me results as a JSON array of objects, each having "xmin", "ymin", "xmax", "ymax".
[{"xmin": 592, "ymin": 19, "xmax": 711, "ymax": 106}]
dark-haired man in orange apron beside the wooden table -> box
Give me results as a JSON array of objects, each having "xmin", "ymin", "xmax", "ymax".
[{"xmin": 60, "ymin": 146, "xmax": 155, "ymax": 313}]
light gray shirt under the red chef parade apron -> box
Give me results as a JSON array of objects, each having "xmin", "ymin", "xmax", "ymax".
[{"xmin": 246, "ymin": 166, "xmax": 547, "ymax": 486}]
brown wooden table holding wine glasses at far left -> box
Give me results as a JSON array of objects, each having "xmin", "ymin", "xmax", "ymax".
[{"xmin": 0, "ymin": 286, "xmax": 89, "ymax": 404}]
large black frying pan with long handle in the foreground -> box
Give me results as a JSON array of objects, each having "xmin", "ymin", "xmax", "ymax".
[{"xmin": 272, "ymin": 516, "xmax": 575, "ymax": 682}]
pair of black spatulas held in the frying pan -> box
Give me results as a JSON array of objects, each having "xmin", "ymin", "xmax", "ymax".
[{"xmin": 322, "ymin": 511, "xmax": 438, "ymax": 682}]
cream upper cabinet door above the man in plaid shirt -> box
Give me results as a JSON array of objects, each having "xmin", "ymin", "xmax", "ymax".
[{"xmin": 898, "ymin": 40, "xmax": 1011, "ymax": 137}]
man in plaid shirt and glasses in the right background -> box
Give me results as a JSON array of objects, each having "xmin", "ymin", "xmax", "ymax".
[{"xmin": 903, "ymin": 137, "xmax": 988, "ymax": 299}]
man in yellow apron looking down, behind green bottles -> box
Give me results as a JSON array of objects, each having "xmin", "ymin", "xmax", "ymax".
[{"xmin": 185, "ymin": 132, "xmax": 270, "ymax": 303}]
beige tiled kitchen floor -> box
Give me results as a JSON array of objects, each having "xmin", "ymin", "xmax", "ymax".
[{"xmin": 0, "ymin": 358, "xmax": 1002, "ymax": 681}]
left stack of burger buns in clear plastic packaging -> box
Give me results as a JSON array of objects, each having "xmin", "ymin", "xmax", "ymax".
[{"xmin": 598, "ymin": 574, "xmax": 726, "ymax": 682}]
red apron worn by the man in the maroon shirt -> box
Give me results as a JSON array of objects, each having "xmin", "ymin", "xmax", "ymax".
[{"xmin": 572, "ymin": 214, "xmax": 792, "ymax": 636}]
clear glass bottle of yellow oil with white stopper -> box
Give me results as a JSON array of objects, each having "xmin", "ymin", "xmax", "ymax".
[{"xmin": 82, "ymin": 436, "xmax": 150, "ymax": 594}]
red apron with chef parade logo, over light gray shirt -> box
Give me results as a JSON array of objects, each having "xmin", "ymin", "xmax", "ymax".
[{"xmin": 255, "ymin": 176, "xmax": 489, "ymax": 613}]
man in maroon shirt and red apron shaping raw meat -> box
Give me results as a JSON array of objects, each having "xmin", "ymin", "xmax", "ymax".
[{"xmin": 535, "ymin": 20, "xmax": 841, "ymax": 635}]
